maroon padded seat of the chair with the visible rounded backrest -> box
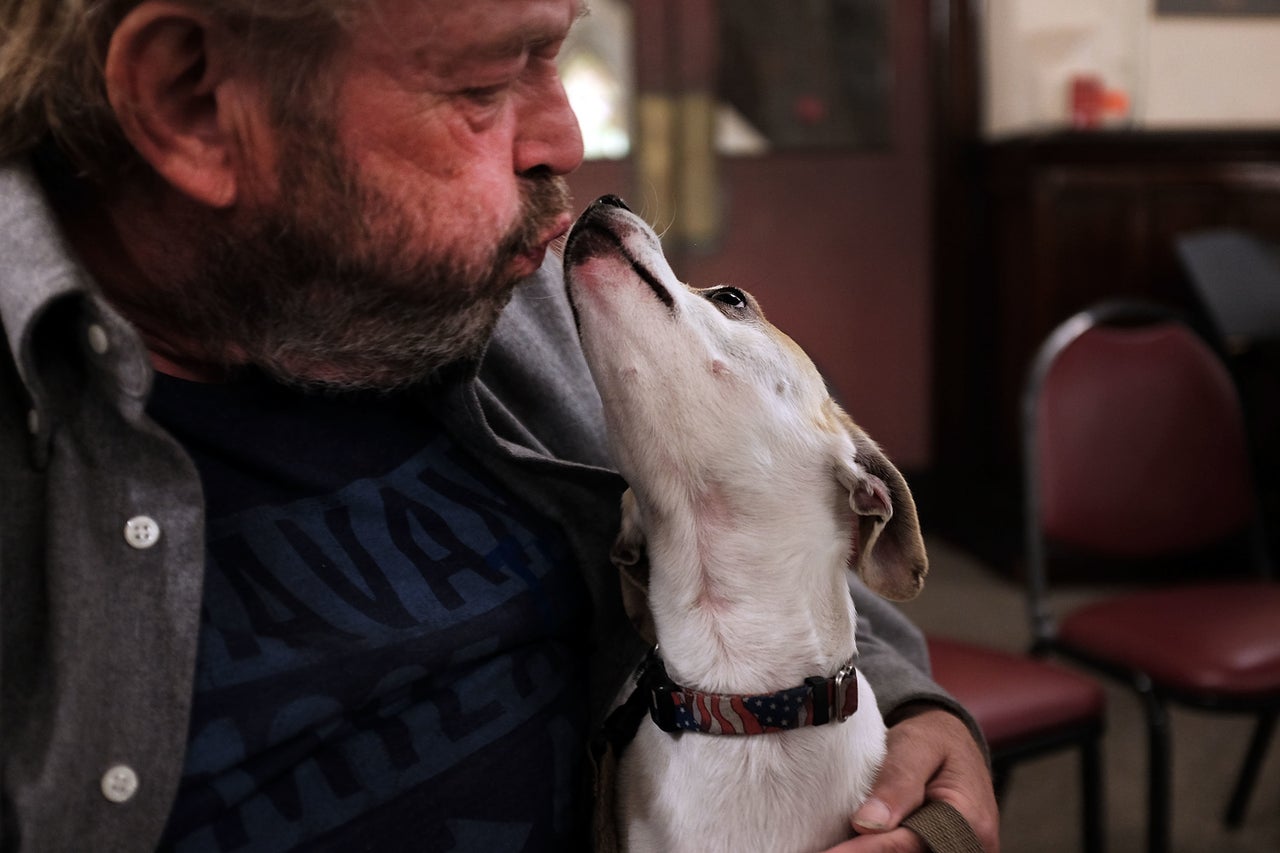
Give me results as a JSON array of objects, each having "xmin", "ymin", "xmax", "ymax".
[{"xmin": 1059, "ymin": 583, "xmax": 1280, "ymax": 699}]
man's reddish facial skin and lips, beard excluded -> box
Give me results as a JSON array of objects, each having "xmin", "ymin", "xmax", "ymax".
[{"xmin": 337, "ymin": 0, "xmax": 582, "ymax": 277}]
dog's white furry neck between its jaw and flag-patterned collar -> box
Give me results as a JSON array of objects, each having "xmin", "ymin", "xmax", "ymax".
[{"xmin": 646, "ymin": 473, "xmax": 855, "ymax": 693}]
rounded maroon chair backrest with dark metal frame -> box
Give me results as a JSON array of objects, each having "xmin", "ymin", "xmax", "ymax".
[{"xmin": 1023, "ymin": 302, "xmax": 1257, "ymax": 639}]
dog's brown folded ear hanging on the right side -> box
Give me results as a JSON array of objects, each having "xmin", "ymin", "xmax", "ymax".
[{"xmin": 836, "ymin": 416, "xmax": 929, "ymax": 601}]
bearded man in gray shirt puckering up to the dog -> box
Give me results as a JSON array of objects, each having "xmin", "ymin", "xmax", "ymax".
[{"xmin": 0, "ymin": 0, "xmax": 997, "ymax": 852}]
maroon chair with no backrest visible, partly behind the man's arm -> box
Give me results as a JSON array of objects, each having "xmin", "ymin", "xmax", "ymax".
[{"xmin": 928, "ymin": 637, "xmax": 1106, "ymax": 853}]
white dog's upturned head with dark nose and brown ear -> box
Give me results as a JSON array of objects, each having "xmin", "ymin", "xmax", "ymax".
[{"xmin": 564, "ymin": 196, "xmax": 927, "ymax": 599}]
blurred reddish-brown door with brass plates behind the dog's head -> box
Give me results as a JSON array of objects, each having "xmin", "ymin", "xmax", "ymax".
[{"xmin": 560, "ymin": 0, "xmax": 931, "ymax": 469}]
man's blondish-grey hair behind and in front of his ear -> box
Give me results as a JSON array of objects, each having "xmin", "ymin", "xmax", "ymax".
[{"xmin": 0, "ymin": 0, "xmax": 360, "ymax": 182}]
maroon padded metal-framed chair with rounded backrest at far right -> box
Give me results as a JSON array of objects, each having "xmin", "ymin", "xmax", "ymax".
[{"xmin": 1024, "ymin": 298, "xmax": 1280, "ymax": 852}]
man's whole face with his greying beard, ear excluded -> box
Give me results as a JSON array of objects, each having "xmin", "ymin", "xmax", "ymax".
[{"xmin": 168, "ymin": 0, "xmax": 582, "ymax": 387}]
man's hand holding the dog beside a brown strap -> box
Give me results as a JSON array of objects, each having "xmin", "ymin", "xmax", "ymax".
[{"xmin": 828, "ymin": 707, "xmax": 1000, "ymax": 853}]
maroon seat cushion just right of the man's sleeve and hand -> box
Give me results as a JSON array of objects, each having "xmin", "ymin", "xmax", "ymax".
[{"xmin": 928, "ymin": 637, "xmax": 1106, "ymax": 752}]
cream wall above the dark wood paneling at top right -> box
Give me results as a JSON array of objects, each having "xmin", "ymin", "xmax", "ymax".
[{"xmin": 983, "ymin": 0, "xmax": 1280, "ymax": 137}]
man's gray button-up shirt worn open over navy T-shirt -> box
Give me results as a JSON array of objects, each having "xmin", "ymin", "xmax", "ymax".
[{"xmin": 0, "ymin": 163, "xmax": 972, "ymax": 853}]
